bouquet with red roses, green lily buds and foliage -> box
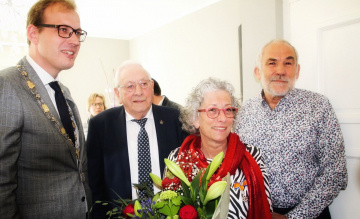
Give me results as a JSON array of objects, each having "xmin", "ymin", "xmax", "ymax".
[{"xmin": 90, "ymin": 152, "xmax": 230, "ymax": 219}]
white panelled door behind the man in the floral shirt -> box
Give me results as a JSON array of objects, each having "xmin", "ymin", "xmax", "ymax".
[{"xmin": 283, "ymin": 0, "xmax": 360, "ymax": 219}]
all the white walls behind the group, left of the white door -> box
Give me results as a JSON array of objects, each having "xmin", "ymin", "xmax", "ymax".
[{"xmin": 0, "ymin": 0, "xmax": 277, "ymax": 125}]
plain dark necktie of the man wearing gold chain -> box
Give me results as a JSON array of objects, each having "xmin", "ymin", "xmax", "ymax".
[{"xmin": 49, "ymin": 81, "xmax": 75, "ymax": 145}]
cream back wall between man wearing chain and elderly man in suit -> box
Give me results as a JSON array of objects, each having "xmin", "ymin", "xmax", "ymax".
[{"xmin": 60, "ymin": 37, "xmax": 129, "ymax": 122}]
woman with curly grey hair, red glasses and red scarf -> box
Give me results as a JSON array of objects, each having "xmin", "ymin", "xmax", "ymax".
[{"xmin": 167, "ymin": 78, "xmax": 271, "ymax": 219}]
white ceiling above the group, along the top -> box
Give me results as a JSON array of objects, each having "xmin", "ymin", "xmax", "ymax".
[{"xmin": 0, "ymin": 0, "xmax": 220, "ymax": 40}]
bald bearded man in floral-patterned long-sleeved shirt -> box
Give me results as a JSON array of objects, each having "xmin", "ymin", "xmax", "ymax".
[{"xmin": 237, "ymin": 40, "xmax": 347, "ymax": 218}]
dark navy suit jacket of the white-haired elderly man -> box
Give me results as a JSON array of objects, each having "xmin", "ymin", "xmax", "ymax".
[{"xmin": 86, "ymin": 104, "xmax": 187, "ymax": 216}]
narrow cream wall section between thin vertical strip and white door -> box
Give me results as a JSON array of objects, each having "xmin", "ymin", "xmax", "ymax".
[{"xmin": 240, "ymin": 0, "xmax": 282, "ymax": 101}]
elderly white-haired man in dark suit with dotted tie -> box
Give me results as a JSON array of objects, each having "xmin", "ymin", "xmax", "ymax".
[{"xmin": 87, "ymin": 61, "xmax": 186, "ymax": 218}]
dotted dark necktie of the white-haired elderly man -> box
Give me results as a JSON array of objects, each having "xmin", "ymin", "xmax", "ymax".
[{"xmin": 132, "ymin": 118, "xmax": 154, "ymax": 198}]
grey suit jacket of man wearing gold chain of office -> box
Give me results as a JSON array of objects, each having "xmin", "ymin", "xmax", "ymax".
[{"xmin": 0, "ymin": 58, "xmax": 91, "ymax": 219}]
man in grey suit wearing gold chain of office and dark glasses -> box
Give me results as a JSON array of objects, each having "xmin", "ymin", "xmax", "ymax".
[{"xmin": 0, "ymin": 0, "xmax": 91, "ymax": 219}]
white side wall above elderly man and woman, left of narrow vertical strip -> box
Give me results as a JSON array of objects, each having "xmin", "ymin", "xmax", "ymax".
[{"xmin": 130, "ymin": 0, "xmax": 241, "ymax": 104}]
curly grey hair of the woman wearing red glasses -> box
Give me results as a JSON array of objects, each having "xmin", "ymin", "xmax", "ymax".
[{"xmin": 180, "ymin": 78, "xmax": 240, "ymax": 134}]
